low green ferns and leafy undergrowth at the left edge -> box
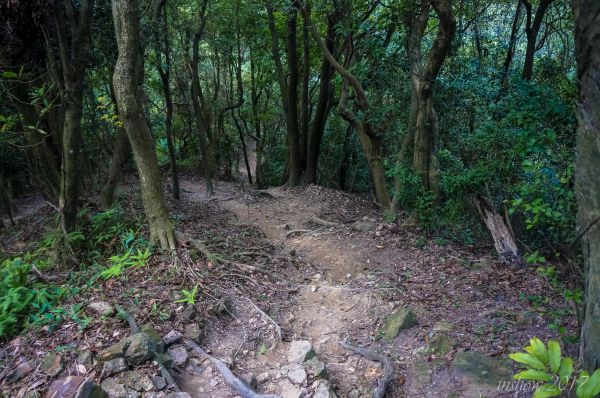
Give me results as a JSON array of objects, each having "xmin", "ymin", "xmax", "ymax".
[{"xmin": 0, "ymin": 207, "xmax": 152, "ymax": 340}]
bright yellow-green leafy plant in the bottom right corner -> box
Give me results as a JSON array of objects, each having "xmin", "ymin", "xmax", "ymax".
[{"xmin": 508, "ymin": 337, "xmax": 600, "ymax": 398}]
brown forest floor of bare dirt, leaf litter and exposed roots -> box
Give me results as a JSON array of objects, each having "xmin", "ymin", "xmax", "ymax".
[{"xmin": 0, "ymin": 175, "xmax": 575, "ymax": 398}]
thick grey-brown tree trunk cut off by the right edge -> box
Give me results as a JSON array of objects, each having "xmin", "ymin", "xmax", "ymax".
[{"xmin": 573, "ymin": 0, "xmax": 600, "ymax": 373}]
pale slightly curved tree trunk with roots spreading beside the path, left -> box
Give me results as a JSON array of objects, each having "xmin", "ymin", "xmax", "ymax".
[{"xmin": 112, "ymin": 0, "xmax": 176, "ymax": 250}]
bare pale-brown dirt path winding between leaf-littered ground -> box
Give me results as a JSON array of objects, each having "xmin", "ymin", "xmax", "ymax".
[{"xmin": 181, "ymin": 178, "xmax": 392, "ymax": 397}]
